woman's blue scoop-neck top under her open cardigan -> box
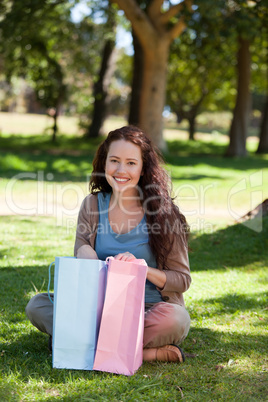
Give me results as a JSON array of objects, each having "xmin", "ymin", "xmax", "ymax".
[{"xmin": 95, "ymin": 193, "xmax": 163, "ymax": 303}]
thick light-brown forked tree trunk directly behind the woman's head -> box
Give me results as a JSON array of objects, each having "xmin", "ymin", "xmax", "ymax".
[{"xmin": 110, "ymin": 0, "xmax": 191, "ymax": 150}]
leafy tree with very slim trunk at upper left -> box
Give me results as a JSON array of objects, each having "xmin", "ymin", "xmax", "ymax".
[{"xmin": 0, "ymin": 0, "xmax": 107, "ymax": 140}]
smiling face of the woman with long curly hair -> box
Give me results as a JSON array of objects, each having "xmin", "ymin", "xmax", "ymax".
[{"xmin": 105, "ymin": 140, "xmax": 143, "ymax": 196}]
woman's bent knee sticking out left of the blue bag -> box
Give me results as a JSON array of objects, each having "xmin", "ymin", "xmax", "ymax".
[{"xmin": 25, "ymin": 293, "xmax": 53, "ymax": 336}]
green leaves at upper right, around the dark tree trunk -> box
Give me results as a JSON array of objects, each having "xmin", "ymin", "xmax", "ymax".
[{"xmin": 167, "ymin": 0, "xmax": 267, "ymax": 141}]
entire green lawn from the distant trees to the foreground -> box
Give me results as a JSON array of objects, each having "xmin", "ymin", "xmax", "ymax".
[{"xmin": 0, "ymin": 118, "xmax": 268, "ymax": 401}]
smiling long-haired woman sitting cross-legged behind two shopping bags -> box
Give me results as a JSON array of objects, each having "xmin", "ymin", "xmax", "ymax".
[{"xmin": 26, "ymin": 126, "xmax": 191, "ymax": 362}]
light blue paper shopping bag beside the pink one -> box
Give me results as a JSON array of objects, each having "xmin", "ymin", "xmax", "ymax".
[{"xmin": 49, "ymin": 257, "xmax": 107, "ymax": 370}]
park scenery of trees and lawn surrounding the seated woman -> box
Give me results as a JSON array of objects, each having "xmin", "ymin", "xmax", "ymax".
[{"xmin": 0, "ymin": 0, "xmax": 268, "ymax": 401}]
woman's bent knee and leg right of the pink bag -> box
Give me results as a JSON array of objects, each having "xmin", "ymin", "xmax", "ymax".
[{"xmin": 143, "ymin": 302, "xmax": 190, "ymax": 348}]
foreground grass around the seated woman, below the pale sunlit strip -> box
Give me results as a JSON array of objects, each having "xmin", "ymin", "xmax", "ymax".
[{"xmin": 0, "ymin": 216, "xmax": 268, "ymax": 401}]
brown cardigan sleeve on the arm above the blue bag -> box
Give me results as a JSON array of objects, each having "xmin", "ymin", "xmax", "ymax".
[{"xmin": 74, "ymin": 194, "xmax": 98, "ymax": 257}]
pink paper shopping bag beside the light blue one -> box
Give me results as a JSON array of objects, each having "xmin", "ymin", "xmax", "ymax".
[{"xmin": 93, "ymin": 258, "xmax": 147, "ymax": 375}]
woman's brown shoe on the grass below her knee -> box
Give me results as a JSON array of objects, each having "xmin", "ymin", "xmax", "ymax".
[{"xmin": 143, "ymin": 345, "xmax": 185, "ymax": 363}]
